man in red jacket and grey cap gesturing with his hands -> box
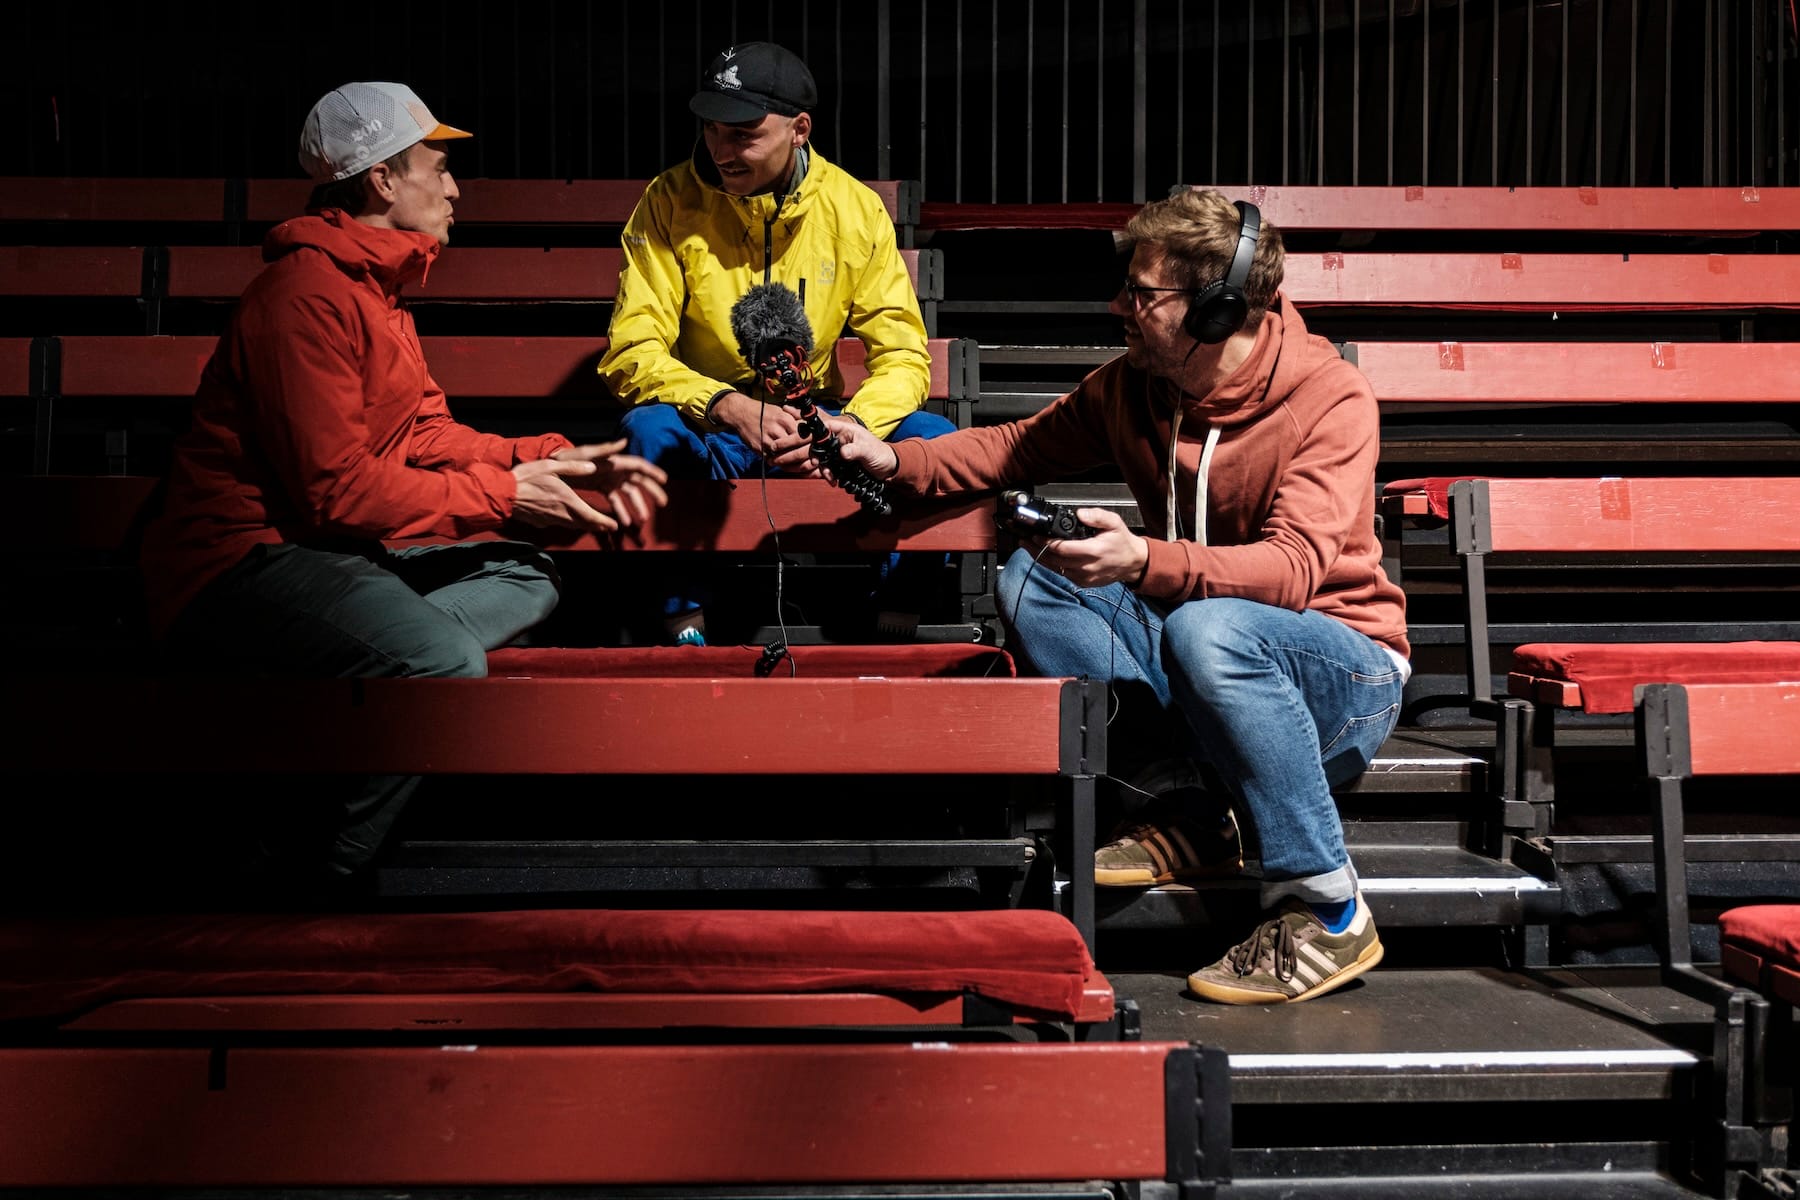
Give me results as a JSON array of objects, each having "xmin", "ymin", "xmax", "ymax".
[{"xmin": 142, "ymin": 83, "xmax": 666, "ymax": 892}]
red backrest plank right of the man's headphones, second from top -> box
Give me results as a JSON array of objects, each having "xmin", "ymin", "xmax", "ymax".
[{"xmin": 1282, "ymin": 252, "xmax": 1800, "ymax": 311}]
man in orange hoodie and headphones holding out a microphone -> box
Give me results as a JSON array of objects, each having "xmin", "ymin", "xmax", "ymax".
[{"xmin": 824, "ymin": 191, "xmax": 1411, "ymax": 1004}]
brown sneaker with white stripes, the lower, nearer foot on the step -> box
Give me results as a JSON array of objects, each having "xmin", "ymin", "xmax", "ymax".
[{"xmin": 1188, "ymin": 892, "xmax": 1382, "ymax": 1004}]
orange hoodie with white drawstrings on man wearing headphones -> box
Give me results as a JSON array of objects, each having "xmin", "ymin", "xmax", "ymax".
[{"xmin": 895, "ymin": 297, "xmax": 1409, "ymax": 655}]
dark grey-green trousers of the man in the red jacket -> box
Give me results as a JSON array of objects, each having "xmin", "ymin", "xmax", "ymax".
[{"xmin": 164, "ymin": 542, "xmax": 562, "ymax": 876}]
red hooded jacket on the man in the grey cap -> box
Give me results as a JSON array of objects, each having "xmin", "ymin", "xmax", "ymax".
[{"xmin": 142, "ymin": 209, "xmax": 571, "ymax": 633}]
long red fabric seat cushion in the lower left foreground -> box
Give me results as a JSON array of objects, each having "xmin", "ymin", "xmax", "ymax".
[{"xmin": 0, "ymin": 909, "xmax": 1094, "ymax": 1018}]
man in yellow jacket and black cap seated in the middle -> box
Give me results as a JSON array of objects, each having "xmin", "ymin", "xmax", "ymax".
[{"xmin": 599, "ymin": 41, "xmax": 954, "ymax": 642}]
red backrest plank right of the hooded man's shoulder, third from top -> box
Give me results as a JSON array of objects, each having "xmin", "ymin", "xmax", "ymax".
[{"xmin": 1354, "ymin": 342, "xmax": 1800, "ymax": 405}]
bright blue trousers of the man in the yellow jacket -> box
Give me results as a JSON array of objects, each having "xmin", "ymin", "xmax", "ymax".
[{"xmin": 619, "ymin": 403, "xmax": 956, "ymax": 629}]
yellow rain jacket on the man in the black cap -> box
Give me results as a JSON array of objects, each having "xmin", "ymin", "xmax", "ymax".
[{"xmin": 599, "ymin": 148, "xmax": 931, "ymax": 437}]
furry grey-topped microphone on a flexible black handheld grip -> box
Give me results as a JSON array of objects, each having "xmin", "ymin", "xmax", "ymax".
[{"xmin": 716, "ymin": 282, "xmax": 893, "ymax": 516}]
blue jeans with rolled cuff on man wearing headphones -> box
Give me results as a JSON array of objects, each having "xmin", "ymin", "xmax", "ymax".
[{"xmin": 997, "ymin": 549, "xmax": 1406, "ymax": 907}]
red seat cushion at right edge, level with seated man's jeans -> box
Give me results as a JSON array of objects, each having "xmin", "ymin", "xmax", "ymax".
[{"xmin": 1512, "ymin": 642, "xmax": 1800, "ymax": 712}]
